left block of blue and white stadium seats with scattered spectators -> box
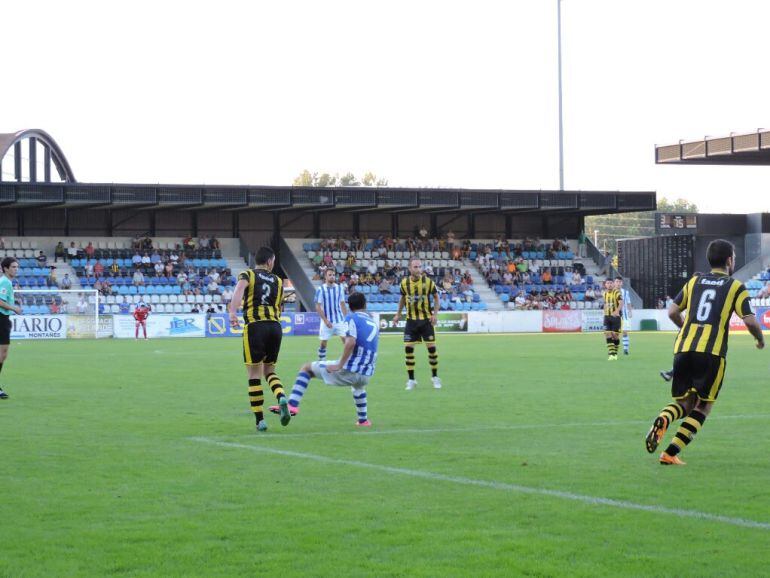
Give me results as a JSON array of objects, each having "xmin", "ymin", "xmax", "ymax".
[{"xmin": 0, "ymin": 237, "xmax": 247, "ymax": 314}]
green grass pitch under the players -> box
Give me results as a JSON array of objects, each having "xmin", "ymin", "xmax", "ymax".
[{"xmin": 0, "ymin": 334, "xmax": 770, "ymax": 577}]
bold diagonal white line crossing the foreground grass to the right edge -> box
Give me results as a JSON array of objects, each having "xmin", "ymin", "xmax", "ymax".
[{"xmin": 188, "ymin": 437, "xmax": 770, "ymax": 530}]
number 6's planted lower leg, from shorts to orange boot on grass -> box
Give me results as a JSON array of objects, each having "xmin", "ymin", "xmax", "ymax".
[{"xmin": 660, "ymin": 354, "xmax": 726, "ymax": 465}]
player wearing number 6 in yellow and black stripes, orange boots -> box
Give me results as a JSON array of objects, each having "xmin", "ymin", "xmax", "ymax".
[{"xmin": 645, "ymin": 239, "xmax": 765, "ymax": 465}]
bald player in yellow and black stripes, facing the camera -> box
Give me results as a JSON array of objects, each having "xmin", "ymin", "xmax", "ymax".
[{"xmin": 393, "ymin": 258, "xmax": 441, "ymax": 391}]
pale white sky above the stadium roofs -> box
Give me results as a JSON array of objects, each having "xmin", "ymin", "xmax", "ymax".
[{"xmin": 0, "ymin": 0, "xmax": 770, "ymax": 212}]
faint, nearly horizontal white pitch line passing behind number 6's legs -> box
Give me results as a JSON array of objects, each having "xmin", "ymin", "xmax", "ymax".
[{"xmin": 213, "ymin": 414, "xmax": 770, "ymax": 439}]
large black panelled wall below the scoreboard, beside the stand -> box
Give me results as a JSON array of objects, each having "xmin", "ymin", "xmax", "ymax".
[{"xmin": 618, "ymin": 235, "xmax": 695, "ymax": 309}]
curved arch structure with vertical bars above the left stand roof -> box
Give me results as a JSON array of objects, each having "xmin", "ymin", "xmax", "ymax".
[{"xmin": 0, "ymin": 128, "xmax": 77, "ymax": 183}]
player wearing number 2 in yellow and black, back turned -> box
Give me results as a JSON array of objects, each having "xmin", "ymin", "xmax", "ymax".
[{"xmin": 228, "ymin": 247, "xmax": 291, "ymax": 431}]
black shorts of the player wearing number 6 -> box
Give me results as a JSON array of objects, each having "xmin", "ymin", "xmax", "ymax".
[{"xmin": 671, "ymin": 351, "xmax": 727, "ymax": 401}]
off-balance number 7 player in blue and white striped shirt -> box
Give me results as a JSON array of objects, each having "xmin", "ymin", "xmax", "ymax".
[{"xmin": 270, "ymin": 293, "xmax": 380, "ymax": 427}]
